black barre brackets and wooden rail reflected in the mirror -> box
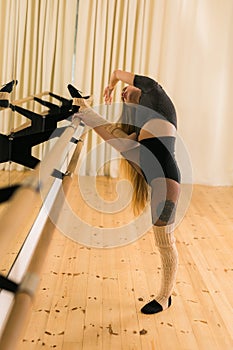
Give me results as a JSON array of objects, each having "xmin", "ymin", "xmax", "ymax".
[{"xmin": 0, "ymin": 91, "xmax": 73, "ymax": 168}]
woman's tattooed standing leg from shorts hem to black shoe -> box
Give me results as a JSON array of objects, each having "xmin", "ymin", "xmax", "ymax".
[{"xmin": 141, "ymin": 179, "xmax": 179, "ymax": 314}]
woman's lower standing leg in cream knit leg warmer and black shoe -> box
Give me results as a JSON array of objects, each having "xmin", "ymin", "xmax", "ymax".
[{"xmin": 141, "ymin": 225, "xmax": 178, "ymax": 314}]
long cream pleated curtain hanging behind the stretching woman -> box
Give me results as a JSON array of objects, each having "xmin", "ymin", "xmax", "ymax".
[{"xmin": 75, "ymin": 0, "xmax": 233, "ymax": 185}]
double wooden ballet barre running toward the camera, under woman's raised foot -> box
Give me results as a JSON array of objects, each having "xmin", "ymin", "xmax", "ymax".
[{"xmin": 0, "ymin": 118, "xmax": 86, "ymax": 350}]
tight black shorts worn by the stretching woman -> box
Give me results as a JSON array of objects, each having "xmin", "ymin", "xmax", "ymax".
[{"xmin": 139, "ymin": 136, "xmax": 181, "ymax": 184}]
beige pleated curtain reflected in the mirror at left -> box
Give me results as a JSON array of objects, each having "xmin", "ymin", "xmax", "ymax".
[{"xmin": 0, "ymin": 0, "xmax": 78, "ymax": 169}]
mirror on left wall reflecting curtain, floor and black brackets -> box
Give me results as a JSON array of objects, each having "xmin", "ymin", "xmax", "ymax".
[{"xmin": 0, "ymin": 0, "xmax": 78, "ymax": 276}]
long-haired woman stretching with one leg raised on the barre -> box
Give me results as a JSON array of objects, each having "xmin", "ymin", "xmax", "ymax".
[{"xmin": 77, "ymin": 70, "xmax": 180, "ymax": 314}]
